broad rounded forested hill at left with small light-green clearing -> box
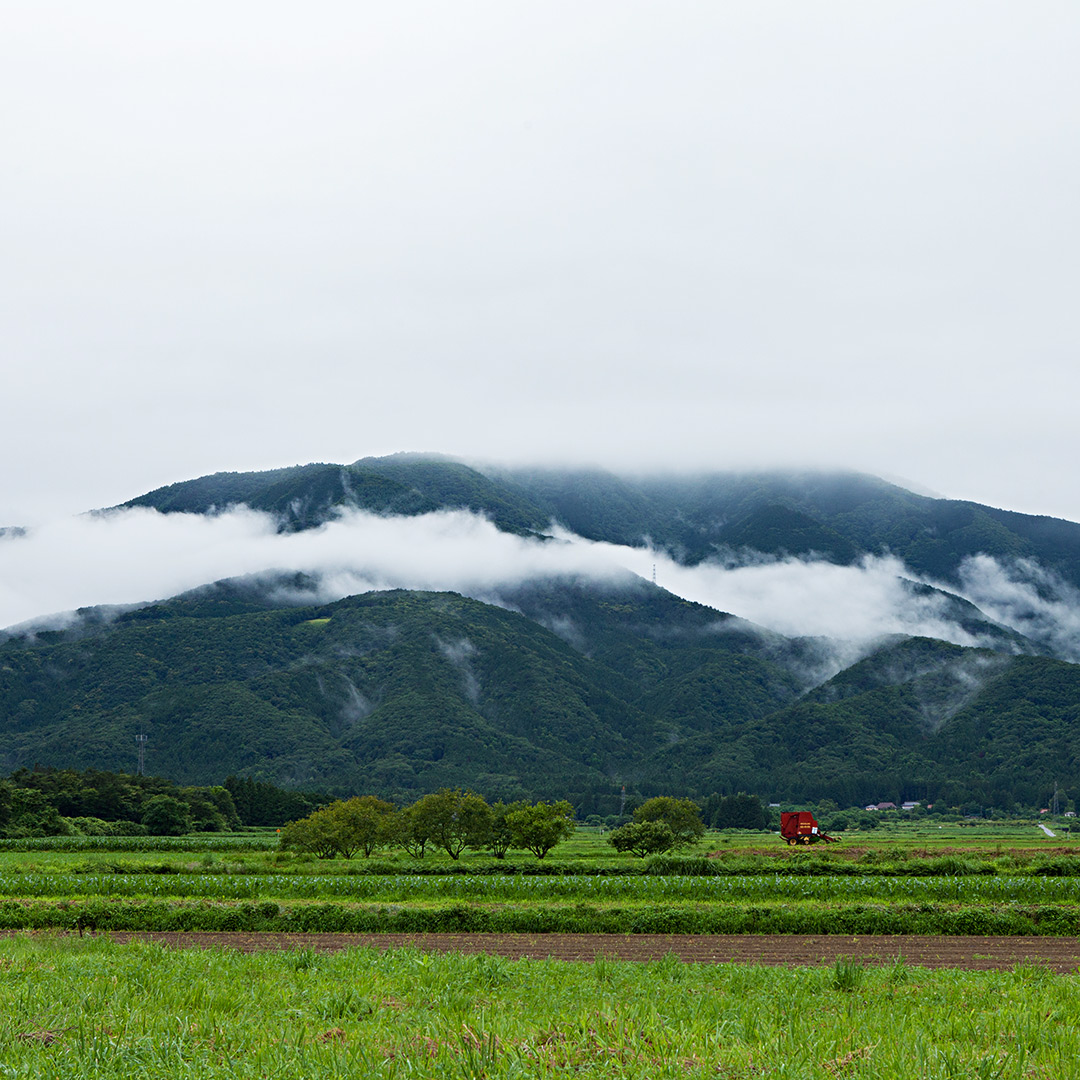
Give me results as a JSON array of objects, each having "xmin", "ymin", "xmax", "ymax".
[{"xmin": 0, "ymin": 592, "xmax": 658, "ymax": 797}]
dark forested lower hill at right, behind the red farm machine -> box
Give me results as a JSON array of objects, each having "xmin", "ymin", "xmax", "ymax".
[{"xmin": 650, "ymin": 638, "xmax": 1080, "ymax": 810}]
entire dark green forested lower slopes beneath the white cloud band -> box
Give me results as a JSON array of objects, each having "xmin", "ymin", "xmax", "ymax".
[{"xmin": 0, "ymin": 578, "xmax": 1080, "ymax": 813}]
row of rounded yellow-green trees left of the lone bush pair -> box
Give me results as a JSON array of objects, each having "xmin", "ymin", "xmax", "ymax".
[{"xmin": 281, "ymin": 788, "xmax": 575, "ymax": 859}]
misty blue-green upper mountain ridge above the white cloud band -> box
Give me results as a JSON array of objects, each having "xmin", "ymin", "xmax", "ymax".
[{"xmin": 118, "ymin": 454, "xmax": 1080, "ymax": 586}]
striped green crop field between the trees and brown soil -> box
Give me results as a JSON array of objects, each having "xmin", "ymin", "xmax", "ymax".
[{"xmin": 0, "ymin": 823, "xmax": 1080, "ymax": 935}]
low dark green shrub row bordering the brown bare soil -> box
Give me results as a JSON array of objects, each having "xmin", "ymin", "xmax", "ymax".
[{"xmin": 0, "ymin": 900, "xmax": 1080, "ymax": 936}]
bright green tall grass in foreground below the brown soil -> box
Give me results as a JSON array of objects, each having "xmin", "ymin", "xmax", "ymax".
[{"xmin": 0, "ymin": 937, "xmax": 1080, "ymax": 1080}]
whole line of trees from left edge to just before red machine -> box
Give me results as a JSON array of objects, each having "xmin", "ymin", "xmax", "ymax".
[{"xmin": 0, "ymin": 766, "xmax": 766, "ymax": 859}]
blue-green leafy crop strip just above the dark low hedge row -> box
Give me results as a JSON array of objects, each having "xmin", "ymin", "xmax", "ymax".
[{"xmin": 6, "ymin": 873, "xmax": 1080, "ymax": 904}]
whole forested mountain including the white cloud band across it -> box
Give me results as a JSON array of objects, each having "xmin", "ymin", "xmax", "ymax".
[{"xmin": 0, "ymin": 455, "xmax": 1080, "ymax": 809}]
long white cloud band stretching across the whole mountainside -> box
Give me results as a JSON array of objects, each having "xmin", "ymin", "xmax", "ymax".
[{"xmin": 0, "ymin": 508, "xmax": 1080, "ymax": 660}]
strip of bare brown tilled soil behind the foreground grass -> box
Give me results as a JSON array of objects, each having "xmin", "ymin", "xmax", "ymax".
[{"xmin": 16, "ymin": 931, "xmax": 1080, "ymax": 974}]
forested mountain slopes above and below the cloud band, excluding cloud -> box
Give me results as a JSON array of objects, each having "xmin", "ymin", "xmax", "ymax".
[{"xmin": 0, "ymin": 455, "xmax": 1080, "ymax": 813}]
